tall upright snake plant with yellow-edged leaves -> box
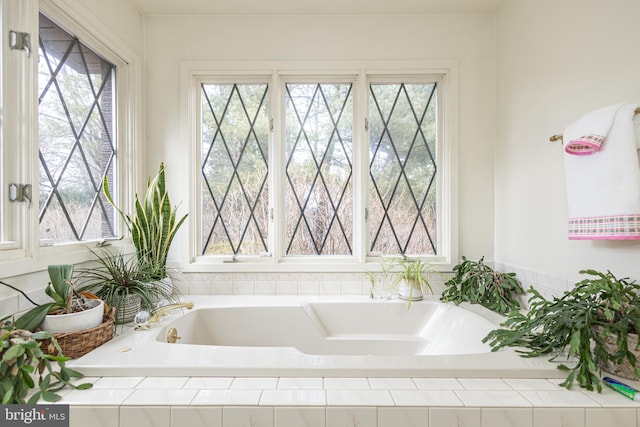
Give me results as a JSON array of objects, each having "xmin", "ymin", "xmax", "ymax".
[{"xmin": 102, "ymin": 163, "xmax": 187, "ymax": 280}]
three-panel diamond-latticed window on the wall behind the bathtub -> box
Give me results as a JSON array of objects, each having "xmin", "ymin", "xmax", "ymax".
[{"xmin": 194, "ymin": 74, "xmax": 446, "ymax": 262}]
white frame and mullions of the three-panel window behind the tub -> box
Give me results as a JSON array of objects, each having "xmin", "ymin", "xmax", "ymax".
[{"xmin": 180, "ymin": 61, "xmax": 458, "ymax": 272}]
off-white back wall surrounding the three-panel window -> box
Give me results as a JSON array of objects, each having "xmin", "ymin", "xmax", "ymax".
[{"xmin": 145, "ymin": 15, "xmax": 495, "ymax": 268}]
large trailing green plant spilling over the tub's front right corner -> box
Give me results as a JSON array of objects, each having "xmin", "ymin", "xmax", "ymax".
[{"xmin": 483, "ymin": 270, "xmax": 640, "ymax": 391}]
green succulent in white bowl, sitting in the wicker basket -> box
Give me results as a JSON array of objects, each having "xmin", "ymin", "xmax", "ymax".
[{"xmin": 15, "ymin": 265, "xmax": 104, "ymax": 333}]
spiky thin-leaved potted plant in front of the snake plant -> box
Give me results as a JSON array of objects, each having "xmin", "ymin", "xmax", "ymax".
[{"xmin": 78, "ymin": 250, "xmax": 178, "ymax": 323}]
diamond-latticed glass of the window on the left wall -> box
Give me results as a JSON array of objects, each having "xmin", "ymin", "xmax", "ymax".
[{"xmin": 38, "ymin": 15, "xmax": 116, "ymax": 242}]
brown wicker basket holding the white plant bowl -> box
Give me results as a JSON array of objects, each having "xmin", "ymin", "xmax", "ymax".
[{"xmin": 42, "ymin": 308, "xmax": 115, "ymax": 359}]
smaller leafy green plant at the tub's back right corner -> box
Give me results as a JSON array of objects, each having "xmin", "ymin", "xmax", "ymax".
[{"xmin": 440, "ymin": 257, "xmax": 525, "ymax": 314}]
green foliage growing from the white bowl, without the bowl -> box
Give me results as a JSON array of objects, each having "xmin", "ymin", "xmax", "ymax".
[{"xmin": 15, "ymin": 264, "xmax": 95, "ymax": 332}]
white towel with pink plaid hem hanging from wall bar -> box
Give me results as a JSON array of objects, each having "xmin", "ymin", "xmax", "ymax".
[{"xmin": 563, "ymin": 104, "xmax": 640, "ymax": 240}]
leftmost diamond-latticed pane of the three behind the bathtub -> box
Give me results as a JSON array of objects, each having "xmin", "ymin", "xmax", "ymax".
[{"xmin": 200, "ymin": 84, "xmax": 269, "ymax": 255}]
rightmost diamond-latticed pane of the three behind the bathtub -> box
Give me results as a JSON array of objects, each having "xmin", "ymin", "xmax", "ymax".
[{"xmin": 369, "ymin": 83, "xmax": 437, "ymax": 255}]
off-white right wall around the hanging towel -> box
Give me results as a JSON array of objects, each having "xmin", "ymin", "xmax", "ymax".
[{"xmin": 495, "ymin": 0, "xmax": 640, "ymax": 280}]
